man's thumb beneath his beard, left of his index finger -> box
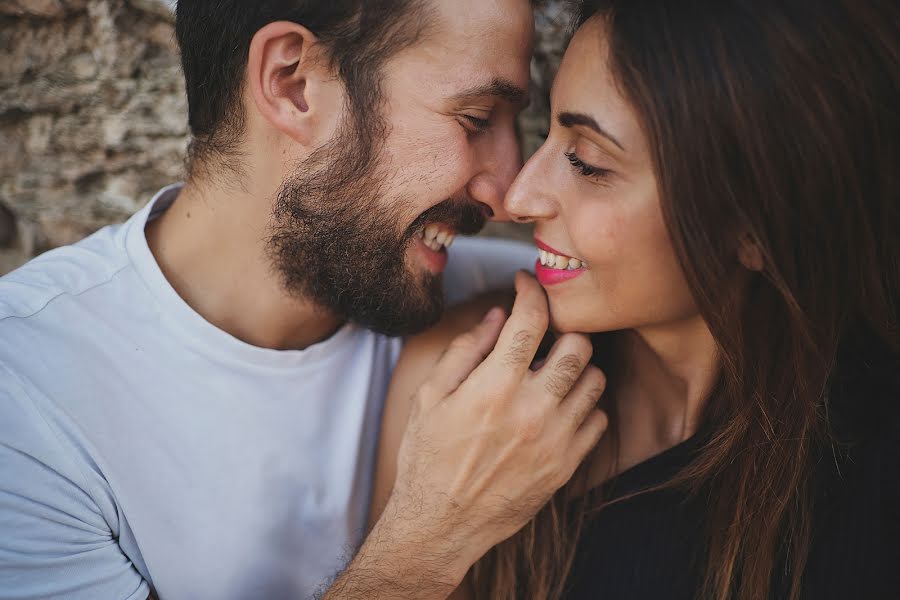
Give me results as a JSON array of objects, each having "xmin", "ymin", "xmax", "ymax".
[{"xmin": 426, "ymin": 307, "xmax": 505, "ymax": 401}]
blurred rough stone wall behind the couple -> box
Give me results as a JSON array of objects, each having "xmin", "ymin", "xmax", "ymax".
[{"xmin": 0, "ymin": 0, "xmax": 568, "ymax": 275}]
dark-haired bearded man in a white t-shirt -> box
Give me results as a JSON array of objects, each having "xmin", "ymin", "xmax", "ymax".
[{"xmin": 0, "ymin": 0, "xmax": 600, "ymax": 600}]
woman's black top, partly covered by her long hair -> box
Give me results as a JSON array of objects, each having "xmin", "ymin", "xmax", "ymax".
[{"xmin": 565, "ymin": 338, "xmax": 900, "ymax": 600}]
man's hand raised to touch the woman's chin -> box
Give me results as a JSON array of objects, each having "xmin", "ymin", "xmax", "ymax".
[{"xmin": 379, "ymin": 273, "xmax": 607, "ymax": 583}]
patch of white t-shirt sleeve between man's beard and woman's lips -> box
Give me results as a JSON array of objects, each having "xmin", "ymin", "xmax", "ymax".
[{"xmin": 444, "ymin": 237, "xmax": 538, "ymax": 306}]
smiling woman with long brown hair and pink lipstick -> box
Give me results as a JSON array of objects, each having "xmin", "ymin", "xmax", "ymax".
[{"xmin": 375, "ymin": 0, "xmax": 900, "ymax": 600}]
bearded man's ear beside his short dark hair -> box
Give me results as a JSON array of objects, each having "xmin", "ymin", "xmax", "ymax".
[{"xmin": 247, "ymin": 21, "xmax": 335, "ymax": 145}]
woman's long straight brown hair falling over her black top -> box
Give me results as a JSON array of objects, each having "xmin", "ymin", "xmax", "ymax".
[{"xmin": 474, "ymin": 0, "xmax": 900, "ymax": 600}]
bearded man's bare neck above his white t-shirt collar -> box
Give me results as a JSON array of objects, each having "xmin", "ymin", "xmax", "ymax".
[{"xmin": 146, "ymin": 181, "xmax": 341, "ymax": 350}]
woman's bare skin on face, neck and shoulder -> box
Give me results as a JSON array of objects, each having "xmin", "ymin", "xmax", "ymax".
[{"xmin": 372, "ymin": 20, "xmax": 762, "ymax": 599}]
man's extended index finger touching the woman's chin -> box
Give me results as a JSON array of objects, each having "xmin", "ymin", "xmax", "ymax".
[{"xmin": 476, "ymin": 272, "xmax": 550, "ymax": 384}]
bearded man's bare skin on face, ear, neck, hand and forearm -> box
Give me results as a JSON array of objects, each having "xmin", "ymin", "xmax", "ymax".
[{"xmin": 147, "ymin": 0, "xmax": 607, "ymax": 600}]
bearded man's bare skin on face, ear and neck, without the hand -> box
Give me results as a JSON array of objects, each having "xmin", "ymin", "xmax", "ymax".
[{"xmin": 147, "ymin": 0, "xmax": 534, "ymax": 349}]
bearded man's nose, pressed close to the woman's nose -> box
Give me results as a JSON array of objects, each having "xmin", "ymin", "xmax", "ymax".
[{"xmin": 468, "ymin": 128, "xmax": 522, "ymax": 221}]
